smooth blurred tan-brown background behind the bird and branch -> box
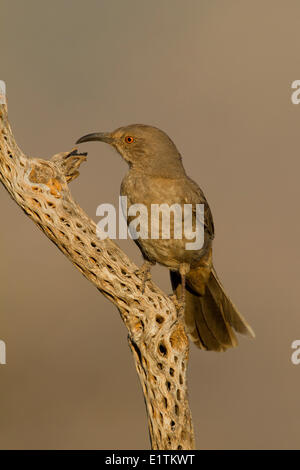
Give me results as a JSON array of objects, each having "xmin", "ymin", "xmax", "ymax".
[{"xmin": 0, "ymin": 0, "xmax": 300, "ymax": 449}]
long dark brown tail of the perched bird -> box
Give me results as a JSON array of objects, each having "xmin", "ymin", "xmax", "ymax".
[{"xmin": 170, "ymin": 268, "xmax": 255, "ymax": 351}]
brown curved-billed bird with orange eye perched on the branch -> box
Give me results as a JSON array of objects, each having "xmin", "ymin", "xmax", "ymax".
[{"xmin": 76, "ymin": 124, "xmax": 255, "ymax": 351}]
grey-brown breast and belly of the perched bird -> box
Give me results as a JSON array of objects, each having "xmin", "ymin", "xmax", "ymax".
[{"xmin": 121, "ymin": 171, "xmax": 208, "ymax": 269}]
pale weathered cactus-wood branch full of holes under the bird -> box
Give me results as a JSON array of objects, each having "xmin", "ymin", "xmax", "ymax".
[{"xmin": 0, "ymin": 85, "xmax": 195, "ymax": 450}]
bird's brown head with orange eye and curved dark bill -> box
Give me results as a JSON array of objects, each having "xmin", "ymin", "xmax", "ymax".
[{"xmin": 76, "ymin": 124, "xmax": 182, "ymax": 175}]
